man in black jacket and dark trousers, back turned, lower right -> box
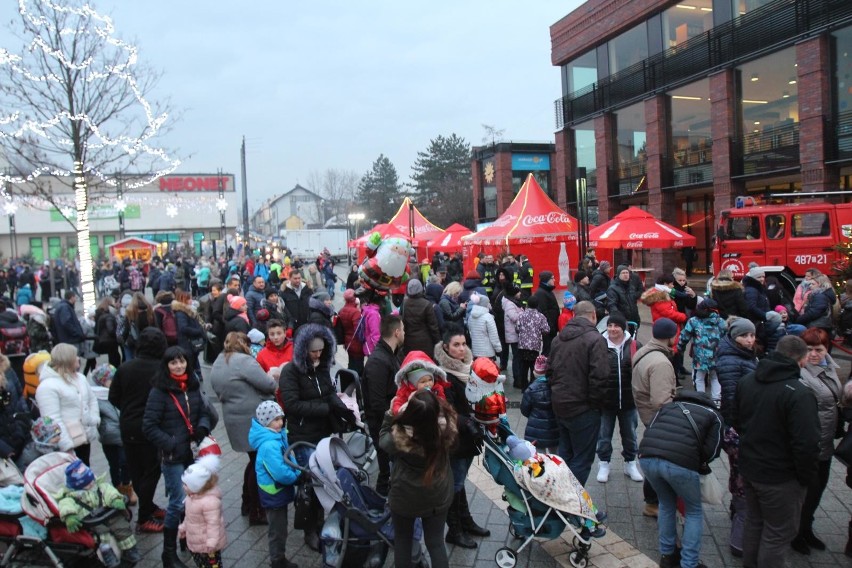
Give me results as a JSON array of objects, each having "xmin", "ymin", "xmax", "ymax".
[{"xmin": 734, "ymin": 335, "xmax": 820, "ymax": 568}]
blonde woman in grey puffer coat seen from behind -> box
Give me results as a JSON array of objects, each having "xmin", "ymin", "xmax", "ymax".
[{"xmin": 210, "ymin": 331, "xmax": 278, "ymax": 525}]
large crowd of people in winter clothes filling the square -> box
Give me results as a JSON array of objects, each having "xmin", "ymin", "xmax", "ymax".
[{"xmin": 0, "ymin": 245, "xmax": 852, "ymax": 568}]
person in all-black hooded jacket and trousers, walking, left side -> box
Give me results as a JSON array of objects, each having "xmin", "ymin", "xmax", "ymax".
[{"xmin": 109, "ymin": 326, "xmax": 166, "ymax": 533}]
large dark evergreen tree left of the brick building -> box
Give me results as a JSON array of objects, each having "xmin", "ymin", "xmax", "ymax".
[{"xmin": 411, "ymin": 134, "xmax": 473, "ymax": 227}]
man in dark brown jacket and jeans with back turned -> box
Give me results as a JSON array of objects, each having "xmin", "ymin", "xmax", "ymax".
[{"xmin": 548, "ymin": 302, "xmax": 609, "ymax": 485}]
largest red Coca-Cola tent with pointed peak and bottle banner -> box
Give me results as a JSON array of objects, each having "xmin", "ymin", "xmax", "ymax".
[{"xmin": 461, "ymin": 174, "xmax": 580, "ymax": 288}]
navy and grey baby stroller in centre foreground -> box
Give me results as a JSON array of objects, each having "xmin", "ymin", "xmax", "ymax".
[{"xmin": 284, "ymin": 437, "xmax": 429, "ymax": 568}]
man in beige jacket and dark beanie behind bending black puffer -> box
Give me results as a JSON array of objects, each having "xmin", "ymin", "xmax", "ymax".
[{"xmin": 633, "ymin": 318, "xmax": 677, "ymax": 517}]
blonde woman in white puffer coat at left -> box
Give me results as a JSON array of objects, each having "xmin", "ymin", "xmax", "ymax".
[{"xmin": 36, "ymin": 343, "xmax": 101, "ymax": 465}]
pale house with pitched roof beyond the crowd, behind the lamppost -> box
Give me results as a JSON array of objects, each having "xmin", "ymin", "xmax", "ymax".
[{"xmin": 251, "ymin": 184, "xmax": 324, "ymax": 237}]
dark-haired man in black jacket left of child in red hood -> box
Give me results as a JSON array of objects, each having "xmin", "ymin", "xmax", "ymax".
[{"xmin": 364, "ymin": 315, "xmax": 405, "ymax": 495}]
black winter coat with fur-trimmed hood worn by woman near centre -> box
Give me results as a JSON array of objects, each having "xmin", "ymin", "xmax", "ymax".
[{"xmin": 278, "ymin": 323, "xmax": 340, "ymax": 444}]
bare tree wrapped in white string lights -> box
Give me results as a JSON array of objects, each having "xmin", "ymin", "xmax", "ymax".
[{"xmin": 0, "ymin": 0, "xmax": 180, "ymax": 307}]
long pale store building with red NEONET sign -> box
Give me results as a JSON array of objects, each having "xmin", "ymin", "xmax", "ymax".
[{"xmin": 0, "ymin": 173, "xmax": 240, "ymax": 263}]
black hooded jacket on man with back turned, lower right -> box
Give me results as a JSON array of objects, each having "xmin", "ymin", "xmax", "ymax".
[{"xmin": 734, "ymin": 351, "xmax": 820, "ymax": 486}]
